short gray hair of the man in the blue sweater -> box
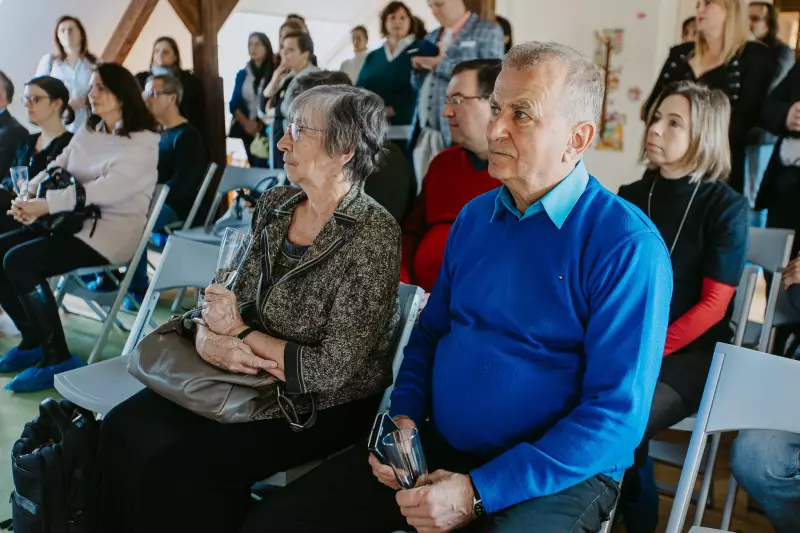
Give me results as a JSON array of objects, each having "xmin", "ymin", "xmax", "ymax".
[{"xmin": 503, "ymin": 41, "xmax": 605, "ymax": 124}]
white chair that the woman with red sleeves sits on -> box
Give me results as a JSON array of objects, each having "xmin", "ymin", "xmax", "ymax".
[{"xmin": 649, "ymin": 265, "xmax": 761, "ymax": 526}]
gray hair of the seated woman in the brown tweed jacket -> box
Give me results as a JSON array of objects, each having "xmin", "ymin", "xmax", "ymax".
[{"xmin": 289, "ymin": 85, "xmax": 389, "ymax": 184}]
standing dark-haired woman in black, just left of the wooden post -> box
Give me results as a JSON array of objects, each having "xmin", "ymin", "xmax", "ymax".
[{"xmin": 136, "ymin": 37, "xmax": 205, "ymax": 132}]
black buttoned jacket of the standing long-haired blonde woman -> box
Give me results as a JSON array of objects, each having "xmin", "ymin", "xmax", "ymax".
[{"xmin": 644, "ymin": 41, "xmax": 774, "ymax": 192}]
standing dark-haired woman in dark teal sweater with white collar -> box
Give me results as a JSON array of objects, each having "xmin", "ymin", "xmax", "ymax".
[{"xmin": 356, "ymin": 2, "xmax": 417, "ymax": 130}]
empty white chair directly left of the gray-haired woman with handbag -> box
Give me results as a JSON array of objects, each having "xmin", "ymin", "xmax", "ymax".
[{"xmin": 55, "ymin": 236, "xmax": 217, "ymax": 415}]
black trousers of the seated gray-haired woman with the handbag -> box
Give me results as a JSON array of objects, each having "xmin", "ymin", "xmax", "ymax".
[{"xmin": 97, "ymin": 389, "xmax": 382, "ymax": 533}]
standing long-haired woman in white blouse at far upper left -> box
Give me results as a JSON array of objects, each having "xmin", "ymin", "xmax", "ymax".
[{"xmin": 36, "ymin": 16, "xmax": 97, "ymax": 133}]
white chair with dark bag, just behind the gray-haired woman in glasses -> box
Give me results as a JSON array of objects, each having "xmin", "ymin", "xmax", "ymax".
[{"xmin": 174, "ymin": 165, "xmax": 286, "ymax": 244}]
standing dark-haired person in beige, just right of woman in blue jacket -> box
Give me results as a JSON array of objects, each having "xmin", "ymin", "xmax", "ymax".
[{"xmin": 264, "ymin": 33, "xmax": 319, "ymax": 168}]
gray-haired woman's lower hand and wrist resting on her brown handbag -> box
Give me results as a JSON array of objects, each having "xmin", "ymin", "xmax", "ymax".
[{"xmin": 194, "ymin": 319, "xmax": 278, "ymax": 376}]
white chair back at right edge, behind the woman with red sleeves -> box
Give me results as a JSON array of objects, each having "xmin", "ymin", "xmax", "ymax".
[{"xmin": 742, "ymin": 228, "xmax": 794, "ymax": 352}]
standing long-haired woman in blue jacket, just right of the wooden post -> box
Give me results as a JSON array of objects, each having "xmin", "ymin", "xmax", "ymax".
[{"xmin": 228, "ymin": 32, "xmax": 274, "ymax": 167}]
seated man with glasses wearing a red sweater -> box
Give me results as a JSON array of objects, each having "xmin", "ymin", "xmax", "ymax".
[{"xmin": 400, "ymin": 59, "xmax": 502, "ymax": 298}]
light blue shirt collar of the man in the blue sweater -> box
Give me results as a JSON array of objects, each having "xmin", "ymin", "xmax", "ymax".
[{"xmin": 491, "ymin": 159, "xmax": 589, "ymax": 229}]
